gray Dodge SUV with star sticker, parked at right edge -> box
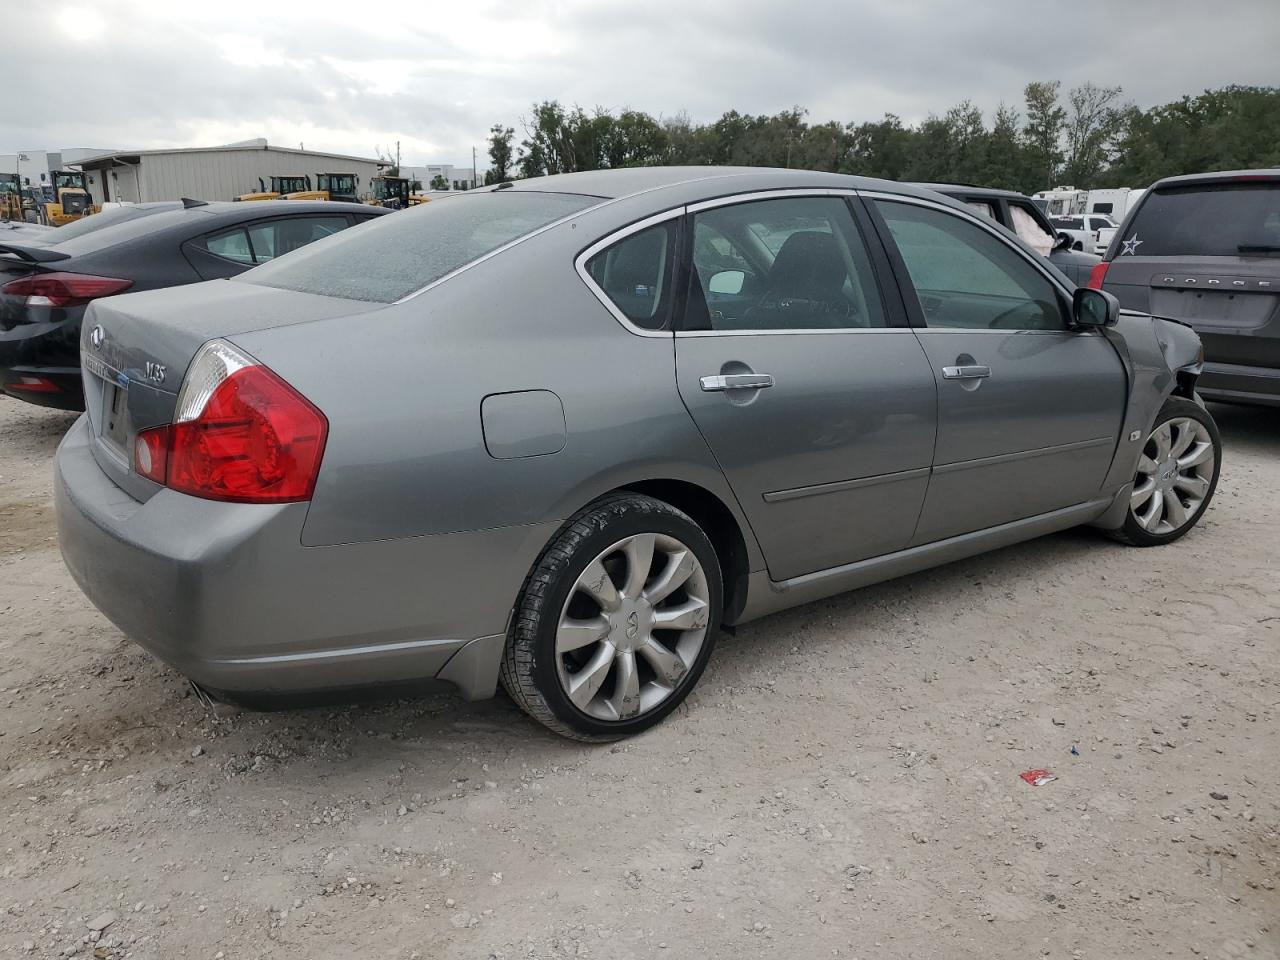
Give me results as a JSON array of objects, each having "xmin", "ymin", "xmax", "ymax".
[{"xmin": 1089, "ymin": 169, "xmax": 1280, "ymax": 406}]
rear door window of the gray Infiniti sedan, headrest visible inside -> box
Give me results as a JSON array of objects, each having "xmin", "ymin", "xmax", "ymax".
[{"xmin": 684, "ymin": 197, "xmax": 887, "ymax": 330}]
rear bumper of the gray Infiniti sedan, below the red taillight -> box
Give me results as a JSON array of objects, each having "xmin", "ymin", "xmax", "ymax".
[{"xmin": 55, "ymin": 417, "xmax": 550, "ymax": 699}]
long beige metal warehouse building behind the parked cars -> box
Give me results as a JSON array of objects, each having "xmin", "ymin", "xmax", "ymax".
[{"xmin": 76, "ymin": 140, "xmax": 387, "ymax": 204}]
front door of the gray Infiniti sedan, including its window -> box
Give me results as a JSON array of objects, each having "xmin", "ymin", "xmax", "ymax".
[{"xmin": 873, "ymin": 196, "xmax": 1126, "ymax": 544}]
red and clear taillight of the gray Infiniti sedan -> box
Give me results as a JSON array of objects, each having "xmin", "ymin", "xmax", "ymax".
[{"xmin": 133, "ymin": 340, "xmax": 329, "ymax": 503}]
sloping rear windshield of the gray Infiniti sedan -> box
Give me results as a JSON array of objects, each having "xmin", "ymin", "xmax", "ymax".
[{"xmin": 237, "ymin": 191, "xmax": 600, "ymax": 303}]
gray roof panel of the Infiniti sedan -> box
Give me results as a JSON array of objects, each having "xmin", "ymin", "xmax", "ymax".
[{"xmin": 499, "ymin": 166, "xmax": 952, "ymax": 200}]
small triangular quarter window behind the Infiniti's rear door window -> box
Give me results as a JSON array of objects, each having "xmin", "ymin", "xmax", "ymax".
[{"xmin": 586, "ymin": 221, "xmax": 676, "ymax": 330}]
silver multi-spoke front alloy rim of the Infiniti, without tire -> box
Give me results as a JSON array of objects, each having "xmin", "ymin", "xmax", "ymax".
[{"xmin": 1129, "ymin": 417, "xmax": 1217, "ymax": 535}]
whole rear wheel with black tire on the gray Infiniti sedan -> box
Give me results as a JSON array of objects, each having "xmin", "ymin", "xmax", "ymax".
[{"xmin": 500, "ymin": 493, "xmax": 723, "ymax": 741}]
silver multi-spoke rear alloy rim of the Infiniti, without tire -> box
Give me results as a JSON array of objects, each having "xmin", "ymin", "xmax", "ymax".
[{"xmin": 556, "ymin": 534, "xmax": 710, "ymax": 721}]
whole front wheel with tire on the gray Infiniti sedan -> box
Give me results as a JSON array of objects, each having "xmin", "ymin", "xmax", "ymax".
[{"xmin": 1112, "ymin": 397, "xmax": 1222, "ymax": 547}]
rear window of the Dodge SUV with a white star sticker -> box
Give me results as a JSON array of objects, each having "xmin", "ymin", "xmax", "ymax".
[{"xmin": 1120, "ymin": 183, "xmax": 1280, "ymax": 257}]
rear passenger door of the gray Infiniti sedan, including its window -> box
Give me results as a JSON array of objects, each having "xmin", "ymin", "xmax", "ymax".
[{"xmin": 675, "ymin": 193, "xmax": 937, "ymax": 580}]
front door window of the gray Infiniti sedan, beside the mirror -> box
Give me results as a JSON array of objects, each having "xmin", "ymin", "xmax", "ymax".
[{"xmin": 877, "ymin": 201, "xmax": 1066, "ymax": 330}]
